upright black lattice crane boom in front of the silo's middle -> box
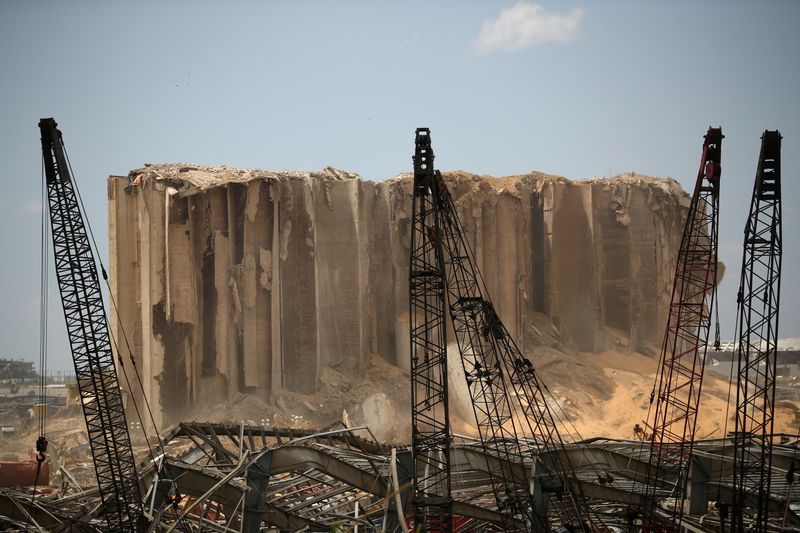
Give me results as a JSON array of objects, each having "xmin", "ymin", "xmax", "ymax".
[{"xmin": 409, "ymin": 127, "xmax": 453, "ymax": 532}]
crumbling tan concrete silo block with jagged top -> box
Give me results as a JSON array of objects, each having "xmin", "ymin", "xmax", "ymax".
[{"xmin": 108, "ymin": 165, "xmax": 688, "ymax": 421}]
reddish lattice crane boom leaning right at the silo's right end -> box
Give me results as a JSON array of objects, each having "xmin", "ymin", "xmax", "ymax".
[{"xmin": 644, "ymin": 128, "xmax": 724, "ymax": 531}]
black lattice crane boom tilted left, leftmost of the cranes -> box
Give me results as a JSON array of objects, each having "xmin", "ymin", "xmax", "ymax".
[{"xmin": 39, "ymin": 118, "xmax": 142, "ymax": 531}]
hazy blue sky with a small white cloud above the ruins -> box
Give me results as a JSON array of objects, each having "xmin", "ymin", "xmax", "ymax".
[{"xmin": 0, "ymin": 0, "xmax": 800, "ymax": 369}]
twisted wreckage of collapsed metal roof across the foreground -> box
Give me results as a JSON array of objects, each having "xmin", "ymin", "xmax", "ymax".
[{"xmin": 0, "ymin": 422, "xmax": 800, "ymax": 532}]
